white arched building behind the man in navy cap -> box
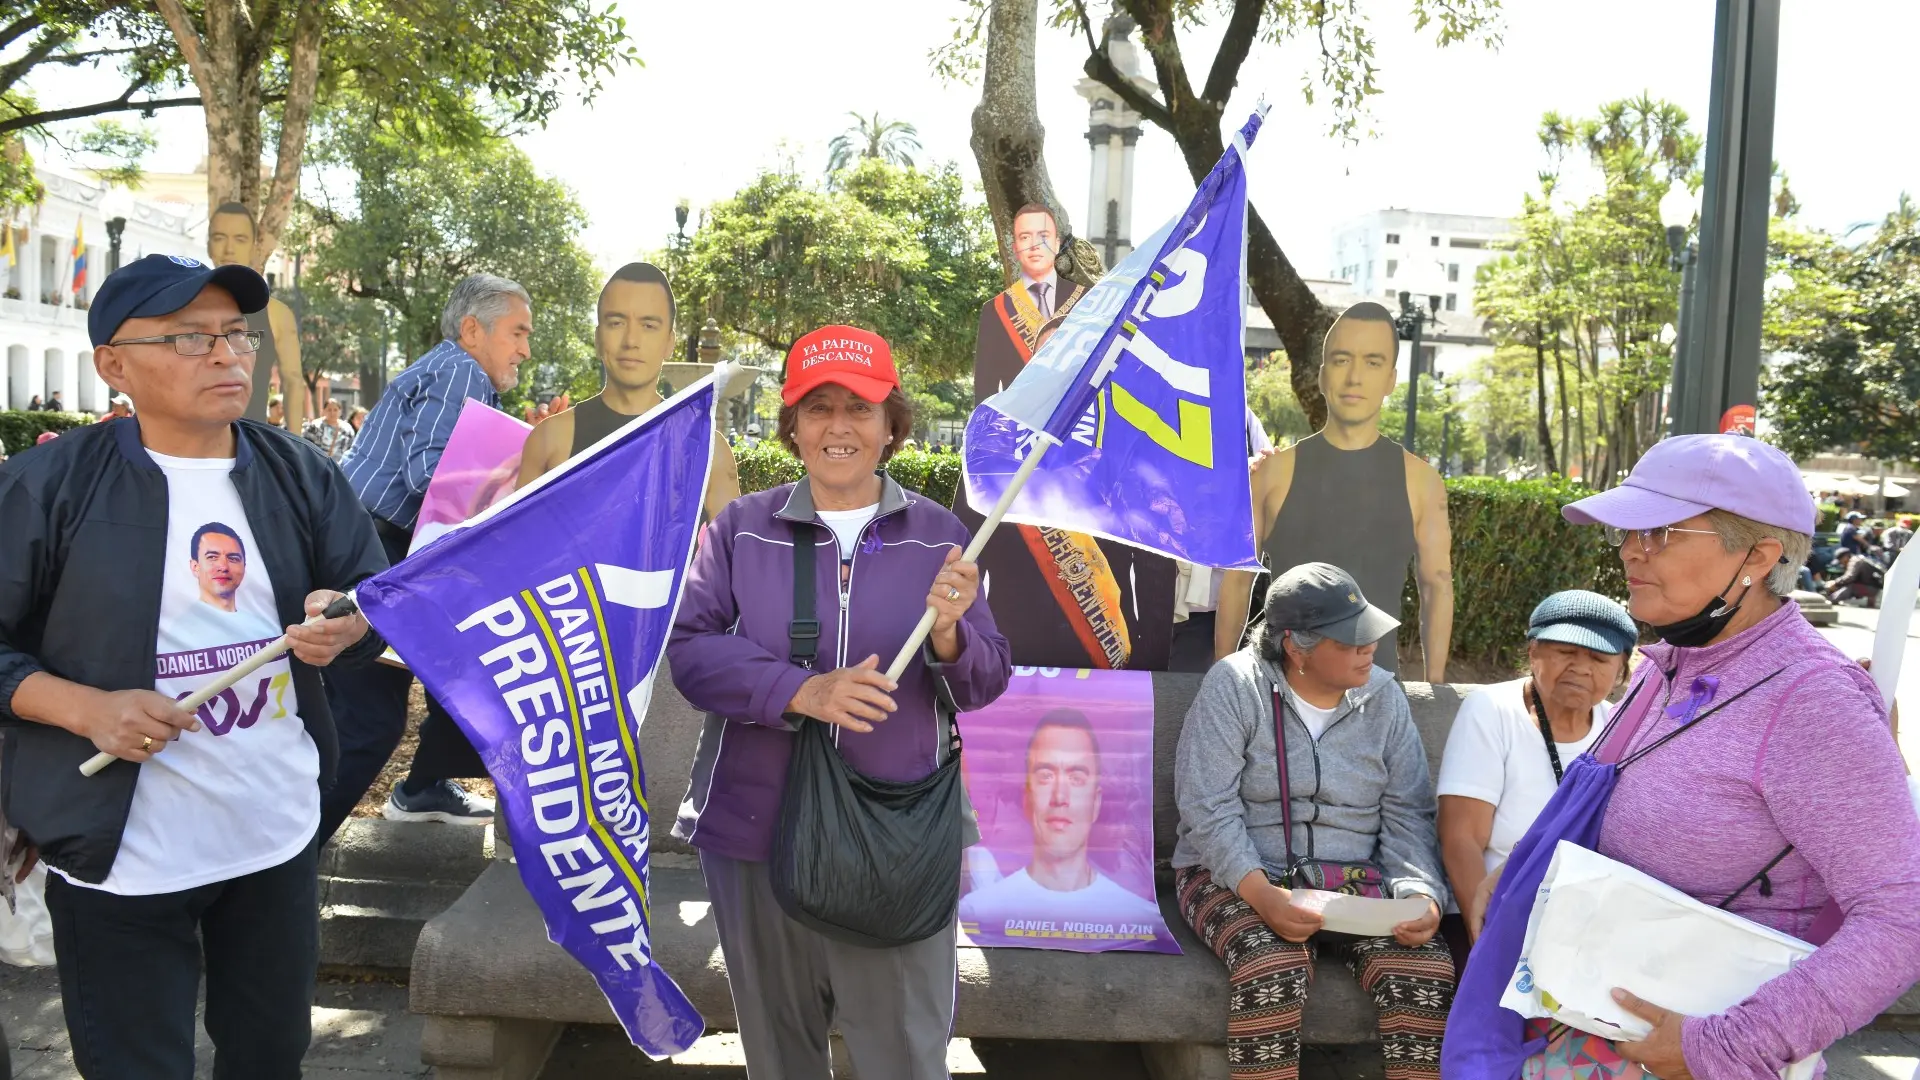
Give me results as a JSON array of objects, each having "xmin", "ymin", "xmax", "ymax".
[{"xmin": 0, "ymin": 171, "xmax": 205, "ymax": 413}]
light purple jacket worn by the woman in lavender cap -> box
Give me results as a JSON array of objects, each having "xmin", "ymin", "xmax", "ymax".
[{"xmin": 1599, "ymin": 600, "xmax": 1920, "ymax": 1080}]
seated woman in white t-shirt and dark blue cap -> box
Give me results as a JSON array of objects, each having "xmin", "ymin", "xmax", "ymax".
[{"xmin": 1434, "ymin": 588, "xmax": 1640, "ymax": 945}]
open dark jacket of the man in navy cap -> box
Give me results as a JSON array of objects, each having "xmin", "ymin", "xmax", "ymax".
[{"xmin": 0, "ymin": 417, "xmax": 386, "ymax": 882}]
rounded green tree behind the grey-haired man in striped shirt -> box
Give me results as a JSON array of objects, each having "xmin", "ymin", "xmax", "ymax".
[{"xmin": 294, "ymin": 129, "xmax": 601, "ymax": 404}]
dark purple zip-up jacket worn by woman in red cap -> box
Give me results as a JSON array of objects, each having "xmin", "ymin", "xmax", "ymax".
[{"xmin": 666, "ymin": 475, "xmax": 1012, "ymax": 863}]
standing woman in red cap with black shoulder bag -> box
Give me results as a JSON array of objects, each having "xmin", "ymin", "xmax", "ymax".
[{"xmin": 668, "ymin": 327, "xmax": 1012, "ymax": 1080}]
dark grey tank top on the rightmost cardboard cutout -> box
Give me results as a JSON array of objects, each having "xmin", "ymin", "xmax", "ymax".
[{"xmin": 1261, "ymin": 434, "xmax": 1417, "ymax": 671}]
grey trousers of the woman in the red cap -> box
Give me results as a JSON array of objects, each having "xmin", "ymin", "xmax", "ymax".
[{"xmin": 701, "ymin": 851, "xmax": 960, "ymax": 1080}]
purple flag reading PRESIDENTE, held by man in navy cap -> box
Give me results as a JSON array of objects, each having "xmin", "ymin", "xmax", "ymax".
[{"xmin": 355, "ymin": 377, "xmax": 714, "ymax": 1057}]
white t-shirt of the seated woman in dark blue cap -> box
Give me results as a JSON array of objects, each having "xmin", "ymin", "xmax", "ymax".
[{"xmin": 1434, "ymin": 678, "xmax": 1613, "ymax": 871}]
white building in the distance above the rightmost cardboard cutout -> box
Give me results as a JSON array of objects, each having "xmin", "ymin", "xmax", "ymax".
[{"xmin": 1329, "ymin": 209, "xmax": 1513, "ymax": 377}]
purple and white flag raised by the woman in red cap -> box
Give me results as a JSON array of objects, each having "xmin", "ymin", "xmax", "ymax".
[{"xmin": 966, "ymin": 105, "xmax": 1263, "ymax": 569}]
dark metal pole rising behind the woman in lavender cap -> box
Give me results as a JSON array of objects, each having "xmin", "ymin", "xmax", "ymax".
[{"xmin": 1674, "ymin": 0, "xmax": 1780, "ymax": 434}]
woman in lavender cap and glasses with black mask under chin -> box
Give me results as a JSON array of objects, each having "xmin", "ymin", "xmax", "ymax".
[{"xmin": 1442, "ymin": 434, "xmax": 1920, "ymax": 1080}]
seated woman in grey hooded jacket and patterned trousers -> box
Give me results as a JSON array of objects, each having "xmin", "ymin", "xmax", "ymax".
[{"xmin": 1173, "ymin": 563, "xmax": 1453, "ymax": 1080}]
